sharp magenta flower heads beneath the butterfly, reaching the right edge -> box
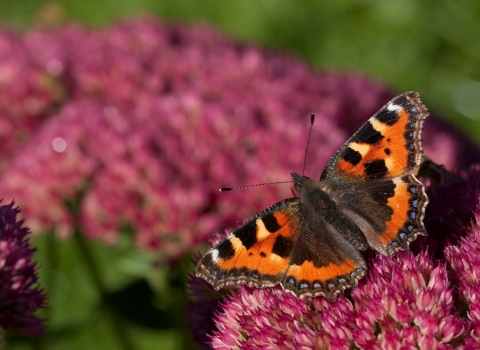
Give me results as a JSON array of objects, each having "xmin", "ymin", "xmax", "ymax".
[{"xmin": 191, "ymin": 166, "xmax": 480, "ymax": 350}]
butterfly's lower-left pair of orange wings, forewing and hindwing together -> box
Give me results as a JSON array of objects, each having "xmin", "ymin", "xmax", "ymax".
[{"xmin": 196, "ymin": 198, "xmax": 366, "ymax": 298}]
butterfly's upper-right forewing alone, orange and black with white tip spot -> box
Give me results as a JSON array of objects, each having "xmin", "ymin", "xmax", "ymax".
[{"xmin": 320, "ymin": 92, "xmax": 429, "ymax": 182}]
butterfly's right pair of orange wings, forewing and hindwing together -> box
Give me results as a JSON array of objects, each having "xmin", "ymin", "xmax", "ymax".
[{"xmin": 321, "ymin": 92, "xmax": 428, "ymax": 255}]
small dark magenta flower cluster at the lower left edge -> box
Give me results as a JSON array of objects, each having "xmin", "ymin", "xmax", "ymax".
[{"xmin": 0, "ymin": 203, "xmax": 45, "ymax": 347}]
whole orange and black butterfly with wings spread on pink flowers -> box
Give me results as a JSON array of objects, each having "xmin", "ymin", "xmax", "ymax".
[{"xmin": 196, "ymin": 92, "xmax": 429, "ymax": 299}]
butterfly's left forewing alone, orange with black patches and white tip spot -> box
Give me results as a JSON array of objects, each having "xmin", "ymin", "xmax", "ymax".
[{"xmin": 196, "ymin": 198, "xmax": 301, "ymax": 289}]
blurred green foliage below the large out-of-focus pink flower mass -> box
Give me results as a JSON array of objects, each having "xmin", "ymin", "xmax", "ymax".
[{"xmin": 6, "ymin": 234, "xmax": 195, "ymax": 350}]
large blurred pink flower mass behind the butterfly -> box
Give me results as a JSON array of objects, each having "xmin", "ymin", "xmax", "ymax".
[{"xmin": 0, "ymin": 20, "xmax": 480, "ymax": 257}]
